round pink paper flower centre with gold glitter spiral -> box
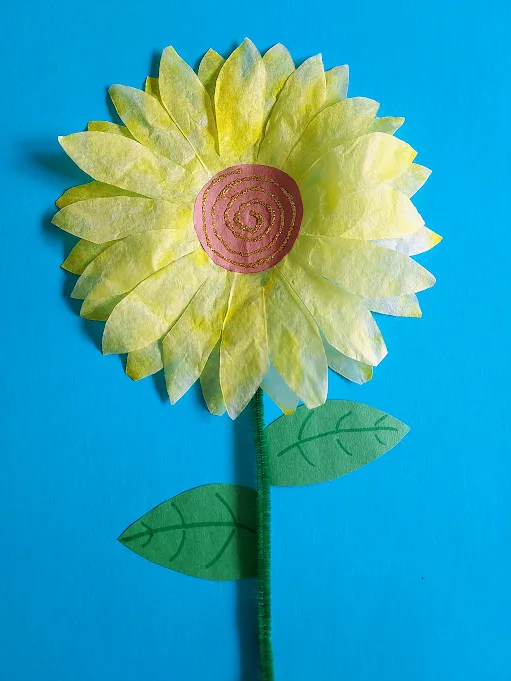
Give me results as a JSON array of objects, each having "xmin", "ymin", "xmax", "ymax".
[{"xmin": 194, "ymin": 164, "xmax": 303, "ymax": 273}]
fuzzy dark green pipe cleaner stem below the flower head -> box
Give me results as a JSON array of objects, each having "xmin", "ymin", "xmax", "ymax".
[{"xmin": 253, "ymin": 388, "xmax": 275, "ymax": 681}]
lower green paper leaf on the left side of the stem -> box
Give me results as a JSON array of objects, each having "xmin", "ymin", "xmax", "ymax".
[{"xmin": 119, "ymin": 484, "xmax": 257, "ymax": 580}]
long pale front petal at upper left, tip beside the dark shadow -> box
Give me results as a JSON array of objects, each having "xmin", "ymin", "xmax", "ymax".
[{"xmin": 59, "ymin": 132, "xmax": 190, "ymax": 199}]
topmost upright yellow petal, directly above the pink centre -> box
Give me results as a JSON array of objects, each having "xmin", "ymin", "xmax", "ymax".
[{"xmin": 215, "ymin": 38, "xmax": 266, "ymax": 166}]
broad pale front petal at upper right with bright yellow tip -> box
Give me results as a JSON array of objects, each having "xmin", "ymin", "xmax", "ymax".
[{"xmin": 300, "ymin": 132, "xmax": 417, "ymax": 207}]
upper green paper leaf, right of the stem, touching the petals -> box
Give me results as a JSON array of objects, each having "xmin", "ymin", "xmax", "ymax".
[{"xmin": 266, "ymin": 400, "xmax": 409, "ymax": 485}]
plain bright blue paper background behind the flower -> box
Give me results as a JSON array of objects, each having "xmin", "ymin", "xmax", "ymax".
[{"xmin": 0, "ymin": 0, "xmax": 511, "ymax": 681}]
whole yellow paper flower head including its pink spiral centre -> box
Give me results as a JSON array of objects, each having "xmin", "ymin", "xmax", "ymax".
[{"xmin": 53, "ymin": 40, "xmax": 440, "ymax": 418}]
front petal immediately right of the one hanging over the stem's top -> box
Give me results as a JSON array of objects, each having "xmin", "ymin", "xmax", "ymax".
[{"xmin": 266, "ymin": 273, "xmax": 328, "ymax": 409}]
